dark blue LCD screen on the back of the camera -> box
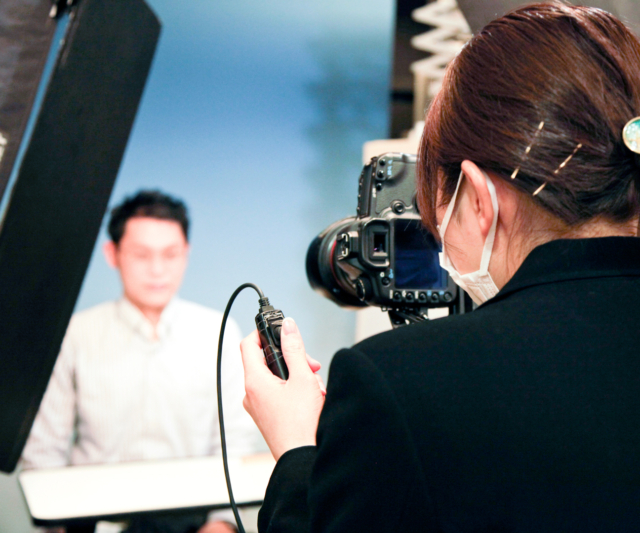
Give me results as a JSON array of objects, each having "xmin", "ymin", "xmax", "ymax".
[{"xmin": 394, "ymin": 219, "xmax": 447, "ymax": 290}]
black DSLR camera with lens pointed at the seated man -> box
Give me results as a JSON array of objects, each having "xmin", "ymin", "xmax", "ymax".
[{"xmin": 306, "ymin": 153, "xmax": 471, "ymax": 326}]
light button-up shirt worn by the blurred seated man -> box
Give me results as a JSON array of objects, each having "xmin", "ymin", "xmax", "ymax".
[{"xmin": 23, "ymin": 298, "xmax": 258, "ymax": 468}]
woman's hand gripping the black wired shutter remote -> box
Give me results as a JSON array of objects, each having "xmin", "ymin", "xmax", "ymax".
[{"xmin": 240, "ymin": 317, "xmax": 326, "ymax": 461}]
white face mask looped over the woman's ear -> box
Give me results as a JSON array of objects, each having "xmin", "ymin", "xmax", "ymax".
[{"xmin": 438, "ymin": 171, "xmax": 498, "ymax": 305}]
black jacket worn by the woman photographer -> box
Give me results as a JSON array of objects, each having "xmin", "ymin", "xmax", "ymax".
[{"xmin": 259, "ymin": 237, "xmax": 640, "ymax": 533}]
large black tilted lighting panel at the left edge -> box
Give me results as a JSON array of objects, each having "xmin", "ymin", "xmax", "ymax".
[{"xmin": 0, "ymin": 0, "xmax": 160, "ymax": 472}]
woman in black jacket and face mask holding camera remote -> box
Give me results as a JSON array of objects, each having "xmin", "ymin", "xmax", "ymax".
[{"xmin": 242, "ymin": 3, "xmax": 640, "ymax": 533}]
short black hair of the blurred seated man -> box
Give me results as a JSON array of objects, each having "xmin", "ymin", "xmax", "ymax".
[{"xmin": 108, "ymin": 191, "xmax": 189, "ymax": 245}]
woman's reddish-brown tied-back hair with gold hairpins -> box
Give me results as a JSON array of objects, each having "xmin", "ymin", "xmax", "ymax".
[{"xmin": 418, "ymin": 2, "xmax": 640, "ymax": 233}]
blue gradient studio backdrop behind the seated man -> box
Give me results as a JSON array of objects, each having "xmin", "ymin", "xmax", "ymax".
[{"xmin": 0, "ymin": 0, "xmax": 394, "ymax": 533}]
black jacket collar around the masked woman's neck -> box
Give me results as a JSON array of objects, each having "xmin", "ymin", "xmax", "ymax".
[{"xmin": 485, "ymin": 237, "xmax": 640, "ymax": 305}]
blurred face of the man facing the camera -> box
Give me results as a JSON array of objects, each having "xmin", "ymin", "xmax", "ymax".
[{"xmin": 105, "ymin": 217, "xmax": 189, "ymax": 310}]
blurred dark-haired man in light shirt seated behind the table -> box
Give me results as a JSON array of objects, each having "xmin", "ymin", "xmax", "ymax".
[{"xmin": 23, "ymin": 191, "xmax": 257, "ymax": 533}]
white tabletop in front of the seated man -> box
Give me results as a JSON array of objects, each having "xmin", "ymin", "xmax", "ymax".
[{"xmin": 19, "ymin": 455, "xmax": 275, "ymax": 525}]
